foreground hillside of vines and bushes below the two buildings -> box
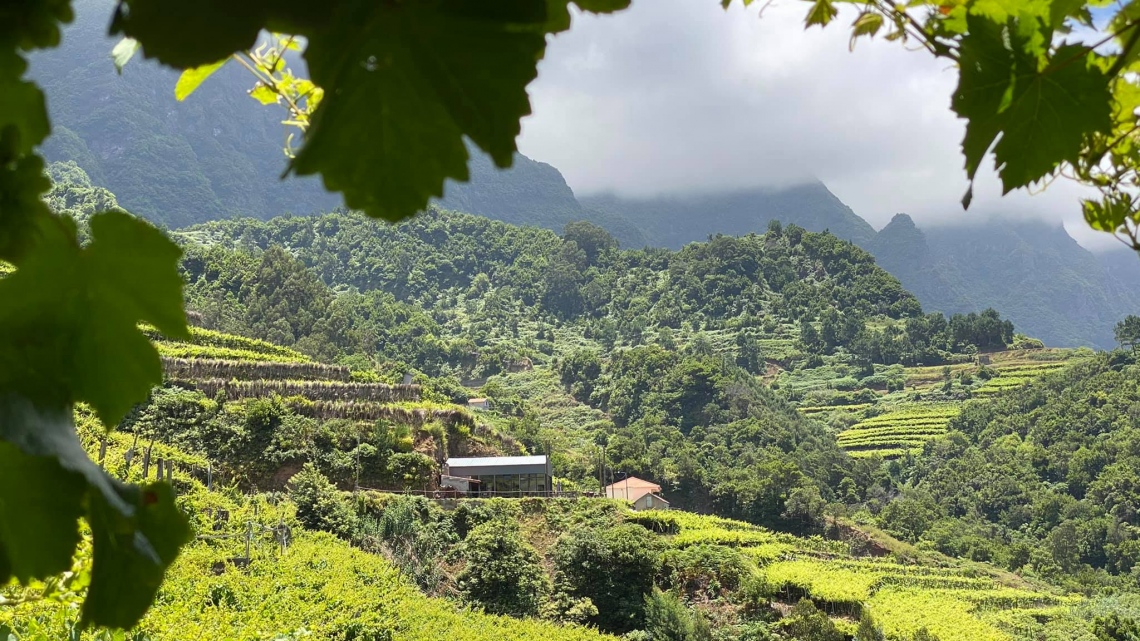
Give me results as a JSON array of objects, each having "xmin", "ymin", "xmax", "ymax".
[{"xmin": 0, "ymin": 408, "xmax": 1103, "ymax": 641}]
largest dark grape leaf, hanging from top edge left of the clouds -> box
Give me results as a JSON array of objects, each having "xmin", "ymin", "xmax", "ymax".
[{"xmin": 292, "ymin": 1, "xmax": 556, "ymax": 220}]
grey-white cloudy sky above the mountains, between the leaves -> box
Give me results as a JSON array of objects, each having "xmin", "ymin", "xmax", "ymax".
[{"xmin": 520, "ymin": 0, "xmax": 1115, "ymax": 248}]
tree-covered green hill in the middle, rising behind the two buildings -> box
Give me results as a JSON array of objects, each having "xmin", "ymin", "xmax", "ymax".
[{"xmin": 178, "ymin": 211, "xmax": 920, "ymax": 524}]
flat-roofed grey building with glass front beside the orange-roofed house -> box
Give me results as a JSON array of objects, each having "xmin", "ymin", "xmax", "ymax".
[{"xmin": 443, "ymin": 455, "xmax": 551, "ymax": 497}]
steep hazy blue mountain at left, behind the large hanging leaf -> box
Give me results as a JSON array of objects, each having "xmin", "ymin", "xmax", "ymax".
[{"xmin": 30, "ymin": 0, "xmax": 581, "ymax": 229}]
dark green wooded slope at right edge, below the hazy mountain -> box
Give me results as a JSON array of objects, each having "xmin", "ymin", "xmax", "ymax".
[{"xmin": 880, "ymin": 352, "xmax": 1140, "ymax": 587}]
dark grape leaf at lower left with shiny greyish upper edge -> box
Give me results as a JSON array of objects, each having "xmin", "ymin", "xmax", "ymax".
[{"xmin": 0, "ymin": 393, "xmax": 190, "ymax": 627}]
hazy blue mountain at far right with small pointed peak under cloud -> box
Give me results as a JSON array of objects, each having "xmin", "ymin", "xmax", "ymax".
[{"xmin": 865, "ymin": 214, "xmax": 1140, "ymax": 348}]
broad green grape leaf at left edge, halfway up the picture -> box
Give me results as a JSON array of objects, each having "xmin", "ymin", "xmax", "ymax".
[{"xmin": 0, "ymin": 212, "xmax": 187, "ymax": 425}]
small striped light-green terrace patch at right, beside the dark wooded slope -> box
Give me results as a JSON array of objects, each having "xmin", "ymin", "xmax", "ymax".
[{"xmin": 838, "ymin": 405, "xmax": 960, "ymax": 457}]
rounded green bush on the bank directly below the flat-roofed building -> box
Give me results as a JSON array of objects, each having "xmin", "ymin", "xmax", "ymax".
[{"xmin": 457, "ymin": 519, "xmax": 551, "ymax": 617}]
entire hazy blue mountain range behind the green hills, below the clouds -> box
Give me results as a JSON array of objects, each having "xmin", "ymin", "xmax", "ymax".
[{"xmin": 31, "ymin": 0, "xmax": 1140, "ymax": 348}]
